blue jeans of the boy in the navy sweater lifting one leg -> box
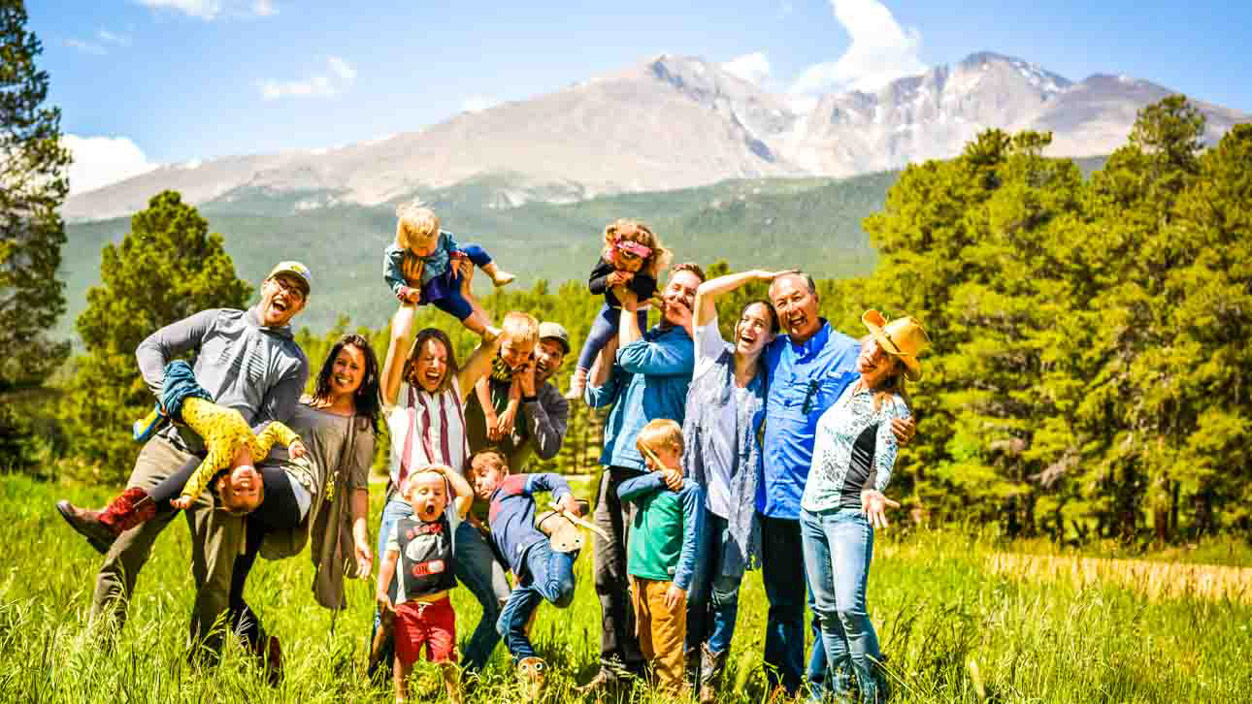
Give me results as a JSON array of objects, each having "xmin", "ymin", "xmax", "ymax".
[{"xmin": 496, "ymin": 540, "xmax": 578, "ymax": 660}]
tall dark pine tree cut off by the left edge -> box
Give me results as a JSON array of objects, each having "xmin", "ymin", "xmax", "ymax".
[{"xmin": 0, "ymin": 0, "xmax": 70, "ymax": 393}]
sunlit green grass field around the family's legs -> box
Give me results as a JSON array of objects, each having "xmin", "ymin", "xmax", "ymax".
[{"xmin": 0, "ymin": 476, "xmax": 1252, "ymax": 704}]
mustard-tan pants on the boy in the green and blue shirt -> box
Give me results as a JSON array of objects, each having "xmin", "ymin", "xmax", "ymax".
[{"xmin": 631, "ymin": 577, "xmax": 687, "ymax": 693}]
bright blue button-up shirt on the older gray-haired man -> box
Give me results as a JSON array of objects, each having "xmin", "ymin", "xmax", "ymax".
[{"xmin": 756, "ymin": 318, "xmax": 860, "ymax": 520}]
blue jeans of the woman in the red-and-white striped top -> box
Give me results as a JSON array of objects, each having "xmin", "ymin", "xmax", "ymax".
[{"xmin": 371, "ymin": 497, "xmax": 508, "ymax": 673}]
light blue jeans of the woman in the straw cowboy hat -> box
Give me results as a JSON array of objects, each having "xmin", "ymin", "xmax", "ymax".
[{"xmin": 800, "ymin": 509, "xmax": 883, "ymax": 701}]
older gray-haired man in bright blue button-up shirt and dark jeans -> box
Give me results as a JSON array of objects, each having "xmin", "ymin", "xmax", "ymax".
[{"xmin": 756, "ymin": 273, "xmax": 914, "ymax": 694}]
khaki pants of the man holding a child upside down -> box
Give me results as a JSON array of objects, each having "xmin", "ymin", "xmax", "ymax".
[{"xmin": 91, "ymin": 437, "xmax": 244, "ymax": 651}]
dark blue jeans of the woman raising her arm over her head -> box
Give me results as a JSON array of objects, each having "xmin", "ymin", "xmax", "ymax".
[{"xmin": 686, "ymin": 509, "xmax": 744, "ymax": 653}]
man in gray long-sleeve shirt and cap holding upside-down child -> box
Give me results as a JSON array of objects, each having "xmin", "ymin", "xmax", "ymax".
[{"xmin": 75, "ymin": 262, "xmax": 312, "ymax": 651}]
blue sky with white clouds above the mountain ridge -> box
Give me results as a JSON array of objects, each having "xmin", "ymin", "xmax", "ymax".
[{"xmin": 28, "ymin": 0, "xmax": 1252, "ymax": 192}]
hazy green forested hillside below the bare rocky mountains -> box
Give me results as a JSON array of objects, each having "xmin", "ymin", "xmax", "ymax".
[{"xmin": 59, "ymin": 173, "xmax": 896, "ymax": 334}]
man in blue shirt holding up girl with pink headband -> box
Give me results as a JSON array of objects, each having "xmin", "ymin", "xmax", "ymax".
[{"xmin": 583, "ymin": 264, "xmax": 705, "ymax": 691}]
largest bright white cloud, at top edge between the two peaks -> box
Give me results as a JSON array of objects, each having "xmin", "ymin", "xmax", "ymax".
[{"xmin": 791, "ymin": 0, "xmax": 926, "ymax": 94}]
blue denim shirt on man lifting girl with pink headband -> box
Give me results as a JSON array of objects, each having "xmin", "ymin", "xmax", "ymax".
[{"xmin": 585, "ymin": 326, "xmax": 696, "ymax": 470}]
